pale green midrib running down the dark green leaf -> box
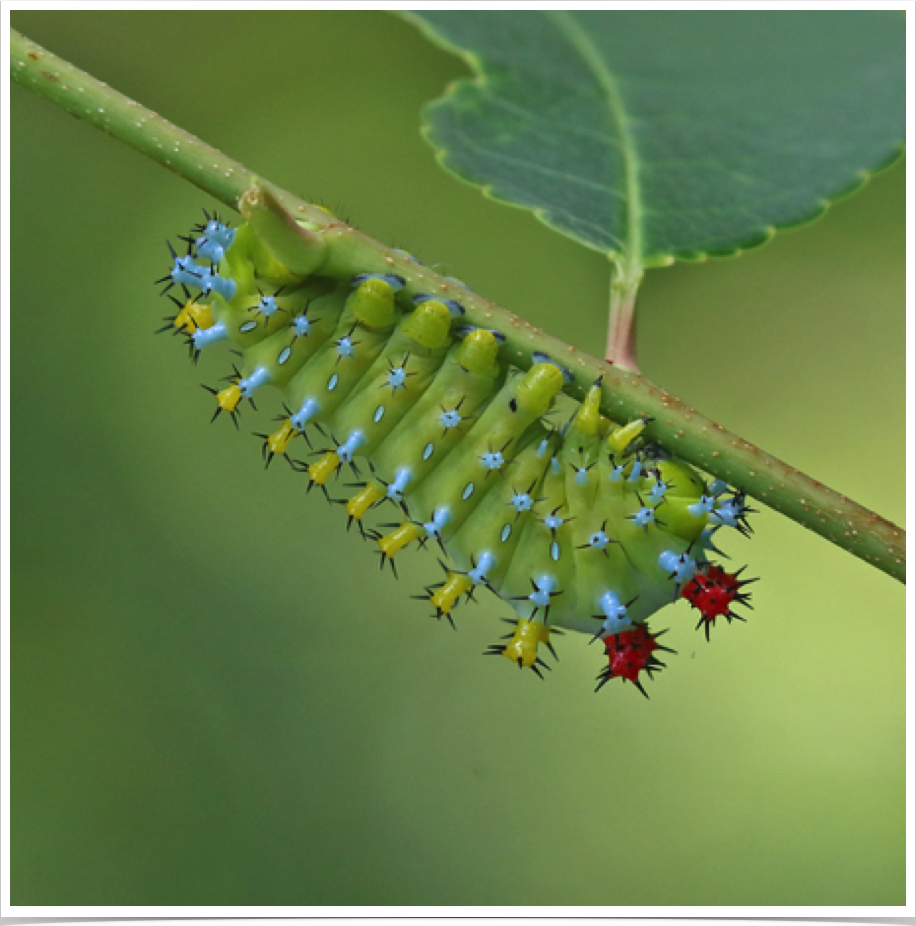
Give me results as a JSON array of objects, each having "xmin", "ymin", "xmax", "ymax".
[{"xmin": 544, "ymin": 10, "xmax": 643, "ymax": 278}]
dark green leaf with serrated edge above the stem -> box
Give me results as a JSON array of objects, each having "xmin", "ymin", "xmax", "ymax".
[{"xmin": 405, "ymin": 10, "xmax": 906, "ymax": 274}]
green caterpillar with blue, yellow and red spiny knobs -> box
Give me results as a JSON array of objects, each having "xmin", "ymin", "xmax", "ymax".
[{"xmin": 156, "ymin": 198, "xmax": 753, "ymax": 695}]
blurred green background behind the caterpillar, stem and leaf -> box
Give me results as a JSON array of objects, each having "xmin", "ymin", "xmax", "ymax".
[{"xmin": 11, "ymin": 12, "xmax": 905, "ymax": 905}]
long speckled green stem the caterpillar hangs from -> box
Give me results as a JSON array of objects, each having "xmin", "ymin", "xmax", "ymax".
[{"xmin": 10, "ymin": 30, "xmax": 906, "ymax": 582}]
